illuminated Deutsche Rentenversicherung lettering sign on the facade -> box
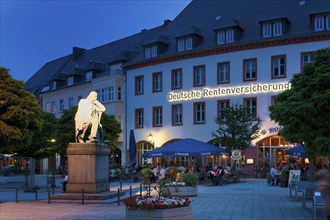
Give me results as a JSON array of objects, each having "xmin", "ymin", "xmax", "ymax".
[{"xmin": 167, "ymin": 82, "xmax": 291, "ymax": 102}]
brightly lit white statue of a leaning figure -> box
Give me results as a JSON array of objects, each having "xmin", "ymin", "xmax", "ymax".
[{"xmin": 75, "ymin": 91, "xmax": 105, "ymax": 143}]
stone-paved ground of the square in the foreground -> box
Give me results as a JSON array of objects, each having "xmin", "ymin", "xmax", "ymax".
[{"xmin": 0, "ymin": 179, "xmax": 326, "ymax": 220}]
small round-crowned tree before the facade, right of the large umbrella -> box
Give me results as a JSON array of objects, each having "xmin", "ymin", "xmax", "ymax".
[{"xmin": 212, "ymin": 106, "xmax": 261, "ymax": 150}]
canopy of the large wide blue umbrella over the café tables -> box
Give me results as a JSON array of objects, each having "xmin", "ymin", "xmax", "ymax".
[{"xmin": 142, "ymin": 138, "xmax": 227, "ymax": 158}]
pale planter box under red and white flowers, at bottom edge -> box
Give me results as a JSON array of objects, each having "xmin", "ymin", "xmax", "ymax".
[{"xmin": 126, "ymin": 207, "xmax": 192, "ymax": 220}]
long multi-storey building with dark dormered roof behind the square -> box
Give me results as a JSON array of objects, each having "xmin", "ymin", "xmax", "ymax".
[{"xmin": 27, "ymin": 0, "xmax": 330, "ymax": 175}]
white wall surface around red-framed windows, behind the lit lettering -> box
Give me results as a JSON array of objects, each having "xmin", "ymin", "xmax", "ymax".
[{"xmin": 126, "ymin": 41, "xmax": 330, "ymax": 150}]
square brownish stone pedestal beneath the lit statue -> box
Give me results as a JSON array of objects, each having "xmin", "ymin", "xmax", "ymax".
[{"xmin": 66, "ymin": 143, "xmax": 110, "ymax": 193}]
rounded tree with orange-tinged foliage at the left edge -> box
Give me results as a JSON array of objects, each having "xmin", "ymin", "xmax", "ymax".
[{"xmin": 0, "ymin": 67, "xmax": 41, "ymax": 153}]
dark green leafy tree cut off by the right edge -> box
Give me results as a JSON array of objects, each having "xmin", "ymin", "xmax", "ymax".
[{"xmin": 269, "ymin": 48, "xmax": 330, "ymax": 179}]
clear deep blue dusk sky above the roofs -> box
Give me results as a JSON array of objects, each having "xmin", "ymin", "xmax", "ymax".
[{"xmin": 0, "ymin": 0, "xmax": 191, "ymax": 81}]
